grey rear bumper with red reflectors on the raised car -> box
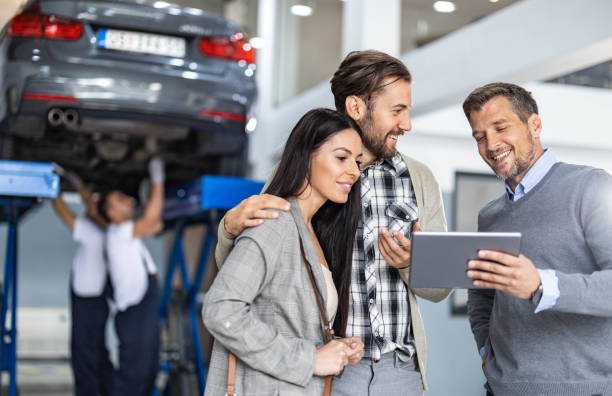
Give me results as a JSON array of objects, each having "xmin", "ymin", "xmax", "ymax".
[{"xmin": 4, "ymin": 56, "xmax": 256, "ymax": 131}]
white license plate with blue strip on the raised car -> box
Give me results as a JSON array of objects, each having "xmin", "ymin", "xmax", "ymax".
[{"xmin": 98, "ymin": 29, "xmax": 185, "ymax": 58}]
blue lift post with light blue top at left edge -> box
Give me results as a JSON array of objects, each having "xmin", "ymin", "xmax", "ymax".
[{"xmin": 0, "ymin": 161, "xmax": 59, "ymax": 396}]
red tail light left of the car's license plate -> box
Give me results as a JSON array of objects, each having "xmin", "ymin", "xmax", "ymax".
[{"xmin": 8, "ymin": 7, "xmax": 83, "ymax": 40}]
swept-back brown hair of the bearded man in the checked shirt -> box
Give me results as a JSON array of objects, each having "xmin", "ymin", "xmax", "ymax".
[{"xmin": 330, "ymin": 50, "xmax": 412, "ymax": 113}]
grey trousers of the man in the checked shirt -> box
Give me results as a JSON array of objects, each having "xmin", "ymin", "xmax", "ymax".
[{"xmin": 332, "ymin": 353, "xmax": 423, "ymax": 396}]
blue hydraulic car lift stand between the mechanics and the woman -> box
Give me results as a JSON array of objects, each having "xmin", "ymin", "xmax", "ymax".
[{"xmin": 154, "ymin": 175, "xmax": 263, "ymax": 396}]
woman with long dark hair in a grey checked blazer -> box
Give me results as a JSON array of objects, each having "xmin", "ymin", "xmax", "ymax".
[{"xmin": 202, "ymin": 109, "xmax": 363, "ymax": 396}]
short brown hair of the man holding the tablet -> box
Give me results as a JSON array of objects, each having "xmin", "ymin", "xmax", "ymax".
[{"xmin": 463, "ymin": 82, "xmax": 538, "ymax": 123}]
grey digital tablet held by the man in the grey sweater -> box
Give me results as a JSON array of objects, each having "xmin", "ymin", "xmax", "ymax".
[{"xmin": 410, "ymin": 232, "xmax": 521, "ymax": 289}]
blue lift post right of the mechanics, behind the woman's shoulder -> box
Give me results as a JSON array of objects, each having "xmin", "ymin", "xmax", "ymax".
[{"xmin": 154, "ymin": 175, "xmax": 264, "ymax": 395}]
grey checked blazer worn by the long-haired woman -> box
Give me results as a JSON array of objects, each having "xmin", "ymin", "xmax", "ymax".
[{"xmin": 202, "ymin": 198, "xmax": 327, "ymax": 396}]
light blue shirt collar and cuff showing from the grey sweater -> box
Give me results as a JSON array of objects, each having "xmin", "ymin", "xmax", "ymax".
[{"xmin": 506, "ymin": 149, "xmax": 561, "ymax": 313}]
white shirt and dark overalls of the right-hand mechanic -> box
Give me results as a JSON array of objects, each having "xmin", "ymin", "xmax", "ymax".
[{"xmin": 105, "ymin": 220, "xmax": 160, "ymax": 396}]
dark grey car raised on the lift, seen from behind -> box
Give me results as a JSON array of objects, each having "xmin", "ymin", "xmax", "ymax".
[{"xmin": 0, "ymin": 0, "xmax": 257, "ymax": 192}]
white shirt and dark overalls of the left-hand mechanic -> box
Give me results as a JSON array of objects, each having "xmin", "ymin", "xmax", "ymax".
[{"xmin": 70, "ymin": 217, "xmax": 113, "ymax": 396}]
